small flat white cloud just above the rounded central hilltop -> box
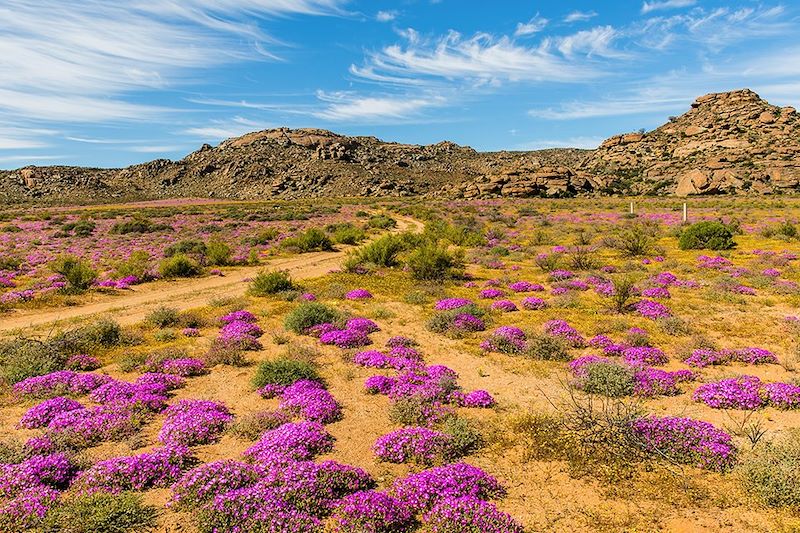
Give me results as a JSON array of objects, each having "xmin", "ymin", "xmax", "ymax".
[{"xmin": 313, "ymin": 91, "xmax": 445, "ymax": 122}]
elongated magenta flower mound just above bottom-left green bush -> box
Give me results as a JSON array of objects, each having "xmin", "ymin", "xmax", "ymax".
[{"xmin": 72, "ymin": 446, "xmax": 192, "ymax": 494}]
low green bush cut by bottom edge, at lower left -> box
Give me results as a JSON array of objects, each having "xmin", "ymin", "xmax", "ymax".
[{"xmin": 41, "ymin": 492, "xmax": 156, "ymax": 533}]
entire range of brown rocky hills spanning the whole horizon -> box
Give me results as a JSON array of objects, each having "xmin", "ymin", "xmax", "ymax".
[{"xmin": 0, "ymin": 89, "xmax": 800, "ymax": 201}]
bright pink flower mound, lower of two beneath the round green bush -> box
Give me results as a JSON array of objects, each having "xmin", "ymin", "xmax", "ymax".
[{"xmin": 244, "ymin": 422, "xmax": 333, "ymax": 464}]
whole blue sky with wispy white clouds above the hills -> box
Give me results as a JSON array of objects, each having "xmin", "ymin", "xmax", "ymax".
[{"xmin": 0, "ymin": 0, "xmax": 800, "ymax": 168}]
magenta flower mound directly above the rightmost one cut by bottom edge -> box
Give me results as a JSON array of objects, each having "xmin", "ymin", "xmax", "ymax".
[{"xmin": 389, "ymin": 463, "xmax": 505, "ymax": 511}]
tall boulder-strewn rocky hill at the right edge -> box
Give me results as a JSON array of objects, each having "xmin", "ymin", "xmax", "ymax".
[{"xmin": 578, "ymin": 89, "xmax": 800, "ymax": 196}]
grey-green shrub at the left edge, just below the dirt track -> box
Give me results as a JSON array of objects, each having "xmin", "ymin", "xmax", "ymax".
[{"xmin": 0, "ymin": 338, "xmax": 67, "ymax": 384}]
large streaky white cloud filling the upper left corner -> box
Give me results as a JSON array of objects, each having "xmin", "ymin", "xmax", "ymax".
[{"xmin": 0, "ymin": 0, "xmax": 346, "ymax": 142}]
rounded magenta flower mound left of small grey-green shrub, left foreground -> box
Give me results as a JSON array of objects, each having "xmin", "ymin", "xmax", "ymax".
[{"xmin": 158, "ymin": 400, "xmax": 233, "ymax": 446}]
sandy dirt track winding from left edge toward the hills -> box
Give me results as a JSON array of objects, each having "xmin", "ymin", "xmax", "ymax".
[{"xmin": 0, "ymin": 216, "xmax": 423, "ymax": 336}]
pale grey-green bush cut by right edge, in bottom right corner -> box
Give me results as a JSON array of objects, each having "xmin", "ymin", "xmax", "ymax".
[{"xmin": 737, "ymin": 431, "xmax": 800, "ymax": 509}]
